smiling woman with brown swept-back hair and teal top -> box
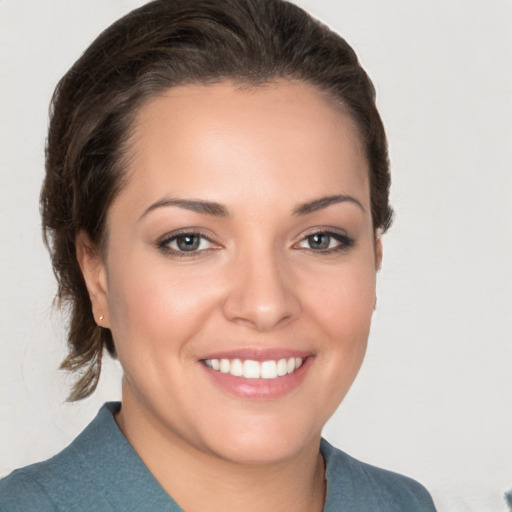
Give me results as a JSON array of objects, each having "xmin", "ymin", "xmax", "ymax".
[{"xmin": 0, "ymin": 0, "xmax": 434, "ymax": 512}]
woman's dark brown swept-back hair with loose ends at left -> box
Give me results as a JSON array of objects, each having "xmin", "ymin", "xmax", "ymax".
[{"xmin": 41, "ymin": 0, "xmax": 392, "ymax": 400}]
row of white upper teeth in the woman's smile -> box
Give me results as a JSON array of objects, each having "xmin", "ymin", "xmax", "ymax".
[{"xmin": 204, "ymin": 357, "xmax": 304, "ymax": 379}]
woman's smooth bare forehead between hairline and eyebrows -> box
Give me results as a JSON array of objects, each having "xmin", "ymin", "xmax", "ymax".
[{"xmin": 119, "ymin": 81, "xmax": 369, "ymax": 212}]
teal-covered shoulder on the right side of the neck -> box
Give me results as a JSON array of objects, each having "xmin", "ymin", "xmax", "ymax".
[{"xmin": 321, "ymin": 440, "xmax": 435, "ymax": 512}]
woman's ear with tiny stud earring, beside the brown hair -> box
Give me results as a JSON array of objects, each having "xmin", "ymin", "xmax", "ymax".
[{"xmin": 76, "ymin": 231, "xmax": 110, "ymax": 327}]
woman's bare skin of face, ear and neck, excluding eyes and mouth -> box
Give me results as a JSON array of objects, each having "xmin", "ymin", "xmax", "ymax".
[{"xmin": 77, "ymin": 81, "xmax": 381, "ymax": 512}]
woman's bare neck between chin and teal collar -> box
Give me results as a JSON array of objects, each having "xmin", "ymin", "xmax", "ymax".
[{"xmin": 116, "ymin": 394, "xmax": 325, "ymax": 512}]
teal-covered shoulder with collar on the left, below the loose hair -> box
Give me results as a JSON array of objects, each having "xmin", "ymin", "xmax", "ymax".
[{"xmin": 0, "ymin": 402, "xmax": 176, "ymax": 512}]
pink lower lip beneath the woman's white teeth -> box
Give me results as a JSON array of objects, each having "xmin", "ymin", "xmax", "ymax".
[{"xmin": 200, "ymin": 357, "xmax": 313, "ymax": 400}]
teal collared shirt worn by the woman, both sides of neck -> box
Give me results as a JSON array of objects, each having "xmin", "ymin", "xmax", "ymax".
[{"xmin": 0, "ymin": 402, "xmax": 435, "ymax": 512}]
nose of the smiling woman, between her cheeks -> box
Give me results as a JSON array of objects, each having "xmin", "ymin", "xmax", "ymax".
[{"xmin": 223, "ymin": 249, "xmax": 301, "ymax": 332}]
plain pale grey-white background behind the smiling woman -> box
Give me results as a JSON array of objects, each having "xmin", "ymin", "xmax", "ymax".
[{"xmin": 0, "ymin": 0, "xmax": 512, "ymax": 512}]
